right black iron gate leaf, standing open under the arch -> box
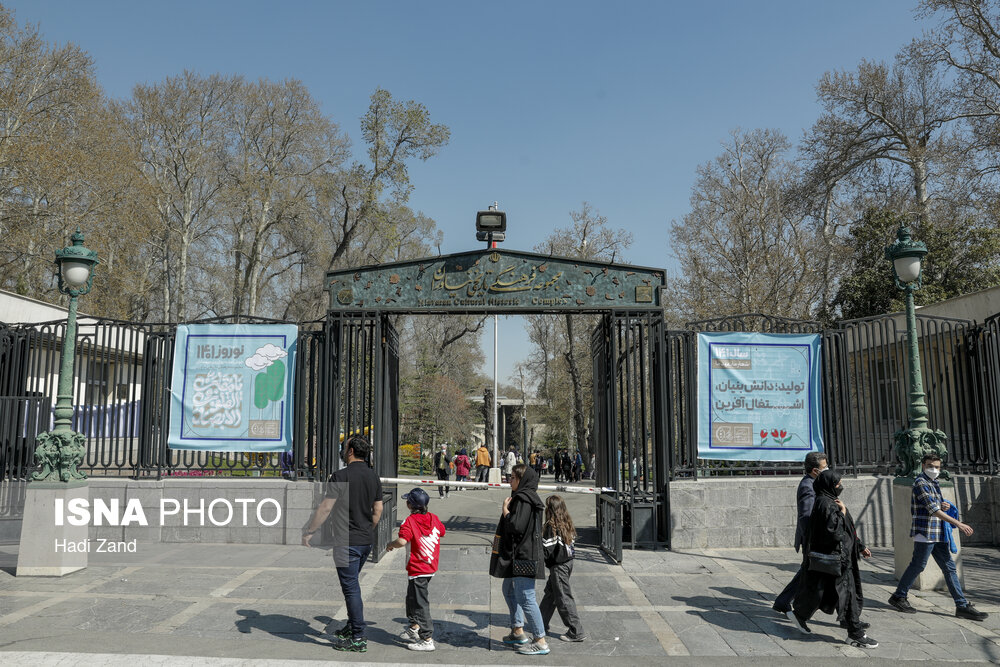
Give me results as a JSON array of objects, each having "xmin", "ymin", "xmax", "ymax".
[{"xmin": 591, "ymin": 313, "xmax": 670, "ymax": 562}]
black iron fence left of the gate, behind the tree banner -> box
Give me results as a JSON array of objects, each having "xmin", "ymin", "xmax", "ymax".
[{"xmin": 0, "ymin": 317, "xmax": 343, "ymax": 479}]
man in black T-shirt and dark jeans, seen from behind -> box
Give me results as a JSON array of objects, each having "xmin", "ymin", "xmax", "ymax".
[{"xmin": 302, "ymin": 435, "xmax": 382, "ymax": 653}]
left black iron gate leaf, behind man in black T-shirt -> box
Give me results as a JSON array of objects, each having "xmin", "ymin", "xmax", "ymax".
[{"xmin": 328, "ymin": 313, "xmax": 399, "ymax": 562}]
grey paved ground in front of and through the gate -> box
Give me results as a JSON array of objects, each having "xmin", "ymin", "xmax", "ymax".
[{"xmin": 0, "ymin": 480, "xmax": 1000, "ymax": 667}]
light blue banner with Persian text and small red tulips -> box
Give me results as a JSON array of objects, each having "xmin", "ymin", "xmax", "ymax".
[{"xmin": 698, "ymin": 333, "xmax": 823, "ymax": 461}]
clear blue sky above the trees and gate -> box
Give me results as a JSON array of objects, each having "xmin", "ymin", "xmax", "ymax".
[{"xmin": 4, "ymin": 0, "xmax": 930, "ymax": 392}]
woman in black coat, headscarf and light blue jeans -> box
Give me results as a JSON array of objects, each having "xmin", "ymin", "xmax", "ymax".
[{"xmin": 490, "ymin": 464, "xmax": 549, "ymax": 655}]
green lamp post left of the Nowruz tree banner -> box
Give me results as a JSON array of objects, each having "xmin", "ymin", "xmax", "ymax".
[{"xmin": 32, "ymin": 228, "xmax": 100, "ymax": 482}]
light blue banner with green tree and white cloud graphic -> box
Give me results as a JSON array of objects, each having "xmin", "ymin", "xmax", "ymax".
[{"xmin": 167, "ymin": 324, "xmax": 298, "ymax": 452}]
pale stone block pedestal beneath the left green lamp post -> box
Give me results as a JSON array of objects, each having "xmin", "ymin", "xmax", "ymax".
[{"xmin": 15, "ymin": 482, "xmax": 90, "ymax": 577}]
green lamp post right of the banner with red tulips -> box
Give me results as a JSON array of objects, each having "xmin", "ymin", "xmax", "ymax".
[{"xmin": 885, "ymin": 225, "xmax": 948, "ymax": 479}]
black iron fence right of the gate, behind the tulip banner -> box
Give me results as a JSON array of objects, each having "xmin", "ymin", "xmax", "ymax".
[{"xmin": 666, "ymin": 314, "xmax": 1000, "ymax": 478}]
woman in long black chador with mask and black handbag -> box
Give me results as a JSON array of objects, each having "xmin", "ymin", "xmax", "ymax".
[{"xmin": 788, "ymin": 469, "xmax": 878, "ymax": 648}]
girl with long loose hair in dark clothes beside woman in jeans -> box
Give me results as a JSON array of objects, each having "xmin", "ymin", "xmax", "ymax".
[{"xmin": 539, "ymin": 495, "xmax": 587, "ymax": 642}]
